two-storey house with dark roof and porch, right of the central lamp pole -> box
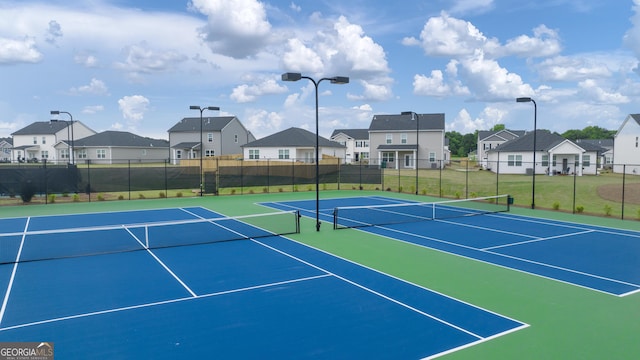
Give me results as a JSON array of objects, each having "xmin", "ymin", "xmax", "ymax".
[{"xmin": 369, "ymin": 114, "xmax": 447, "ymax": 169}]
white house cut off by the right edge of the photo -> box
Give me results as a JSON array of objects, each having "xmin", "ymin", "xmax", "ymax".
[{"xmin": 613, "ymin": 114, "xmax": 640, "ymax": 175}]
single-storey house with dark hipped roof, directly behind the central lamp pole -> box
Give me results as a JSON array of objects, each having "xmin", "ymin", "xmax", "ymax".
[{"xmin": 243, "ymin": 127, "xmax": 346, "ymax": 163}]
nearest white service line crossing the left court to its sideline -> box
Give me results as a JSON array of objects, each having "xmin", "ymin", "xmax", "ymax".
[{"xmin": 0, "ymin": 274, "xmax": 330, "ymax": 332}]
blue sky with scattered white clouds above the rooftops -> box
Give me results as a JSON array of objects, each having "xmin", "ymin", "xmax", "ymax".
[{"xmin": 0, "ymin": 0, "xmax": 640, "ymax": 138}]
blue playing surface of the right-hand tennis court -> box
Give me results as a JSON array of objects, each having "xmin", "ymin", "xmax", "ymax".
[{"xmin": 263, "ymin": 196, "xmax": 640, "ymax": 296}]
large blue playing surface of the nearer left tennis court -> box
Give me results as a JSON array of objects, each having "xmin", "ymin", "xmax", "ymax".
[{"xmin": 0, "ymin": 207, "xmax": 527, "ymax": 359}]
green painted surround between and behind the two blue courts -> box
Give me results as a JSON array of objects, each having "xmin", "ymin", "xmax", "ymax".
[{"xmin": 0, "ymin": 191, "xmax": 640, "ymax": 359}]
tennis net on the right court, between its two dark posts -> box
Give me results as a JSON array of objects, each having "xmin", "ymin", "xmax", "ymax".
[{"xmin": 333, "ymin": 195, "xmax": 511, "ymax": 229}]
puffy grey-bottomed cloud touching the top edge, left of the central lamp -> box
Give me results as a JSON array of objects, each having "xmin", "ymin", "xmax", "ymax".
[{"xmin": 190, "ymin": 0, "xmax": 271, "ymax": 58}]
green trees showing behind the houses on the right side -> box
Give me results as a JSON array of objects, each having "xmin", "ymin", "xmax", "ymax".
[{"xmin": 445, "ymin": 124, "xmax": 616, "ymax": 157}]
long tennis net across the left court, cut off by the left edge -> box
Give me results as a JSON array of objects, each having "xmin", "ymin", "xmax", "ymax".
[{"xmin": 0, "ymin": 211, "xmax": 300, "ymax": 264}]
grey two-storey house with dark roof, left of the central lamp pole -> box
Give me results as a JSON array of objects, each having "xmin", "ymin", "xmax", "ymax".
[{"xmin": 169, "ymin": 116, "xmax": 255, "ymax": 164}]
